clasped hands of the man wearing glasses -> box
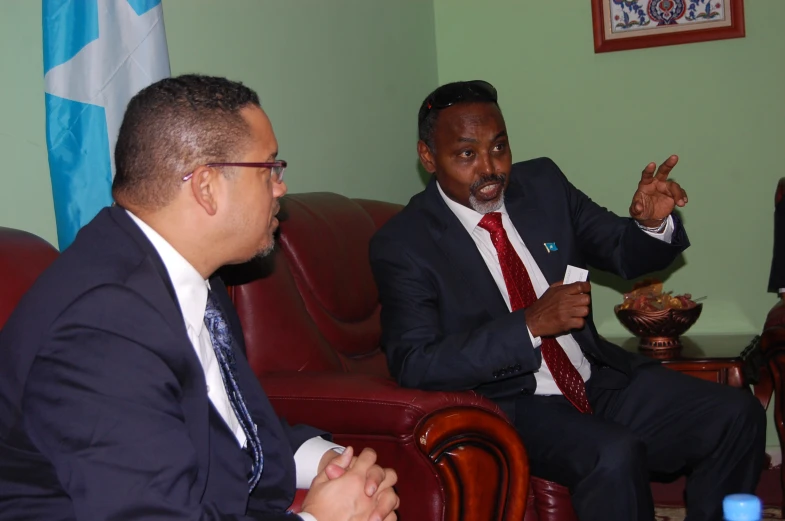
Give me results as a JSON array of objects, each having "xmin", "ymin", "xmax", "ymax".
[{"xmin": 302, "ymin": 447, "xmax": 400, "ymax": 521}]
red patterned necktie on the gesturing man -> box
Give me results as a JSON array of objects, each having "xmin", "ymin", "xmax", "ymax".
[{"xmin": 479, "ymin": 212, "xmax": 592, "ymax": 413}]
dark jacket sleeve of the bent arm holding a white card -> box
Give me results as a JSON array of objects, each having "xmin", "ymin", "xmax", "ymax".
[{"xmin": 371, "ymin": 235, "xmax": 540, "ymax": 391}]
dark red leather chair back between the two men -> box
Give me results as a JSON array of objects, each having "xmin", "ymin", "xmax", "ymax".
[{"xmin": 224, "ymin": 193, "xmax": 401, "ymax": 376}]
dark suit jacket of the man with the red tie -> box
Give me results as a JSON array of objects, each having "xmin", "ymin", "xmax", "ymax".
[{"xmin": 370, "ymin": 158, "xmax": 689, "ymax": 419}]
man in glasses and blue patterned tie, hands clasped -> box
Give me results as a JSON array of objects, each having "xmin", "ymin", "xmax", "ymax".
[{"xmin": 0, "ymin": 75, "xmax": 398, "ymax": 521}]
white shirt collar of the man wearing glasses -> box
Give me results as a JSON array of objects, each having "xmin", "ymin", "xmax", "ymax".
[{"xmin": 126, "ymin": 210, "xmax": 210, "ymax": 333}]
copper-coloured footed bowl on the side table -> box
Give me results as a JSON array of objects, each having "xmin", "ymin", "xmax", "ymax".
[{"xmin": 613, "ymin": 303, "xmax": 703, "ymax": 351}]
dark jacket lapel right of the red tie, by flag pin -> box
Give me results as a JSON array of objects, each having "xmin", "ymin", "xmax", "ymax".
[{"xmin": 505, "ymin": 182, "xmax": 565, "ymax": 285}]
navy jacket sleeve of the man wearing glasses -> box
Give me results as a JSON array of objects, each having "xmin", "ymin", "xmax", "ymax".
[{"xmin": 23, "ymin": 286, "xmax": 292, "ymax": 521}]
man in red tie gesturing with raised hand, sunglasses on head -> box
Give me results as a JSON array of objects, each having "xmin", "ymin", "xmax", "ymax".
[{"xmin": 370, "ymin": 81, "xmax": 765, "ymax": 521}]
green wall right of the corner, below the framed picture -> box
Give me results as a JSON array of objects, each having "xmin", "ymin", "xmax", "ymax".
[{"xmin": 435, "ymin": 0, "xmax": 785, "ymax": 336}]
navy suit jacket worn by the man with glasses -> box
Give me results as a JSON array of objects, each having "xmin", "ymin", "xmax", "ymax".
[{"xmin": 0, "ymin": 207, "xmax": 323, "ymax": 520}]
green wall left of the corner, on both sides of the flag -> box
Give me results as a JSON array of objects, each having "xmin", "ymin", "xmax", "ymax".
[{"xmin": 0, "ymin": 0, "xmax": 437, "ymax": 248}]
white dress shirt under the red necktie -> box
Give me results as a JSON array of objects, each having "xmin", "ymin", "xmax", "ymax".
[{"xmin": 436, "ymin": 182, "xmax": 673, "ymax": 395}]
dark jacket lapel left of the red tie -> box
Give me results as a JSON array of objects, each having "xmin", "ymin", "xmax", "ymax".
[{"xmin": 425, "ymin": 178, "xmax": 510, "ymax": 317}]
